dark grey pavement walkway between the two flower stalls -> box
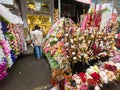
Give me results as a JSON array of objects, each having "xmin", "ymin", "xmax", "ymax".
[{"xmin": 0, "ymin": 46, "xmax": 52, "ymax": 90}]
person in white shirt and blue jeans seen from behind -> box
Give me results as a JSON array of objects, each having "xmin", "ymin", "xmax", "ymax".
[{"xmin": 31, "ymin": 25, "xmax": 43, "ymax": 58}]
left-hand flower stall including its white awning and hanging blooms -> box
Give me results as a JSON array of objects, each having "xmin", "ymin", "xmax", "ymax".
[{"xmin": 0, "ymin": 4, "xmax": 25, "ymax": 80}]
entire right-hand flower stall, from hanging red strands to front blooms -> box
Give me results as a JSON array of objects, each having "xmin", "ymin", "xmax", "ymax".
[{"xmin": 43, "ymin": 1, "xmax": 120, "ymax": 90}]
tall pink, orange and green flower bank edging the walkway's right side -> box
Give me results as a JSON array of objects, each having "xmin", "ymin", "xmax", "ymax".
[{"xmin": 43, "ymin": 18, "xmax": 73, "ymax": 83}]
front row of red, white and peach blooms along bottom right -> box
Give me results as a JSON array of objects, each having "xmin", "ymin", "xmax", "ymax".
[{"xmin": 65, "ymin": 60, "xmax": 120, "ymax": 90}]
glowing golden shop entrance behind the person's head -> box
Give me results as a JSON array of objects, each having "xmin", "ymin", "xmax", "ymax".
[{"xmin": 27, "ymin": 14, "xmax": 51, "ymax": 36}]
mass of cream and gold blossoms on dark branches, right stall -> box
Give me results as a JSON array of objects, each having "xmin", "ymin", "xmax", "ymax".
[{"xmin": 64, "ymin": 21, "xmax": 117, "ymax": 63}]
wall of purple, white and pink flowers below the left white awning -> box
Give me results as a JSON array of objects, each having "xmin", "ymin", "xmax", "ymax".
[{"xmin": 0, "ymin": 11, "xmax": 24, "ymax": 80}]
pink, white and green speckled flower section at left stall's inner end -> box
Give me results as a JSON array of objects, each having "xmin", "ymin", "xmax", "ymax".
[{"xmin": 7, "ymin": 24, "xmax": 25, "ymax": 56}]
